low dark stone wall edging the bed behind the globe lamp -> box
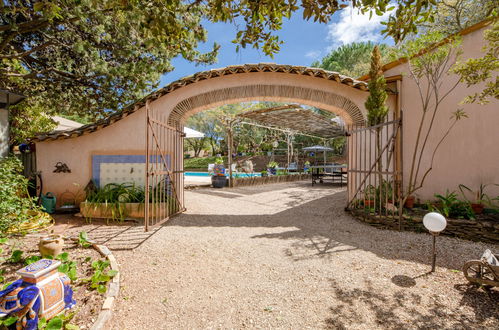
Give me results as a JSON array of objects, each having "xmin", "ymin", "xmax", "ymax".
[{"xmin": 351, "ymin": 210, "xmax": 499, "ymax": 244}]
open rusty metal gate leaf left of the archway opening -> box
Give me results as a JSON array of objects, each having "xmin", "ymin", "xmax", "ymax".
[{"xmin": 144, "ymin": 101, "xmax": 185, "ymax": 231}]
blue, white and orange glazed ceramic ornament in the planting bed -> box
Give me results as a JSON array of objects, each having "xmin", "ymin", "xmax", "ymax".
[{"xmin": 0, "ymin": 259, "xmax": 76, "ymax": 330}]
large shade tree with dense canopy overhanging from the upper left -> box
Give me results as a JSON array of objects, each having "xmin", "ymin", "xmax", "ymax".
[{"xmin": 0, "ymin": 0, "xmax": 450, "ymax": 141}]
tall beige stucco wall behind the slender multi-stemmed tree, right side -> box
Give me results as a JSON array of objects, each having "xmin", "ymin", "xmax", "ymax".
[{"xmin": 385, "ymin": 24, "xmax": 499, "ymax": 199}]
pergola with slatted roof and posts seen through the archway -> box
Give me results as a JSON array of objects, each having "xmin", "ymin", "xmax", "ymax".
[{"xmin": 222, "ymin": 104, "xmax": 345, "ymax": 186}]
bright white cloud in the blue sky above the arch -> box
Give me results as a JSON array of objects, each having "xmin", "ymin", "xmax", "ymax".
[{"xmin": 328, "ymin": 7, "xmax": 395, "ymax": 49}]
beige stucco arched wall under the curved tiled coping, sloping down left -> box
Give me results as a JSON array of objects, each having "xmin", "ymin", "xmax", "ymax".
[{"xmin": 37, "ymin": 72, "xmax": 378, "ymax": 201}]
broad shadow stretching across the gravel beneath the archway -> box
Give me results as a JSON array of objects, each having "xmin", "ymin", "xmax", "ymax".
[{"xmin": 166, "ymin": 186, "xmax": 488, "ymax": 275}]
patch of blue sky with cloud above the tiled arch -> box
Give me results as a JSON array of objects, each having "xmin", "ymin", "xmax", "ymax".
[{"xmin": 160, "ymin": 7, "xmax": 393, "ymax": 87}]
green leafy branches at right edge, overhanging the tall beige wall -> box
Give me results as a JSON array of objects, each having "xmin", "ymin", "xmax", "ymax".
[{"xmin": 453, "ymin": 17, "xmax": 499, "ymax": 104}]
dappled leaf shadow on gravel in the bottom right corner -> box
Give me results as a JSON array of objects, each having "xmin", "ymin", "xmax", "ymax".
[{"xmin": 325, "ymin": 280, "xmax": 499, "ymax": 329}]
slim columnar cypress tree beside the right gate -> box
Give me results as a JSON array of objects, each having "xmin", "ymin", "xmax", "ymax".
[{"xmin": 365, "ymin": 46, "xmax": 388, "ymax": 185}]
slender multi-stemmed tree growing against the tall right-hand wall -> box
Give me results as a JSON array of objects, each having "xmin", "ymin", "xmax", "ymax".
[{"xmin": 398, "ymin": 32, "xmax": 467, "ymax": 221}]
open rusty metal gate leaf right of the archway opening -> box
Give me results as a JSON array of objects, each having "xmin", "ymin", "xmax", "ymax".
[{"xmin": 347, "ymin": 119, "xmax": 402, "ymax": 220}]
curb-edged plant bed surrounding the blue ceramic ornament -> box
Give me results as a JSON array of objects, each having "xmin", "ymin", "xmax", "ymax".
[{"xmin": 0, "ymin": 235, "xmax": 115, "ymax": 329}]
